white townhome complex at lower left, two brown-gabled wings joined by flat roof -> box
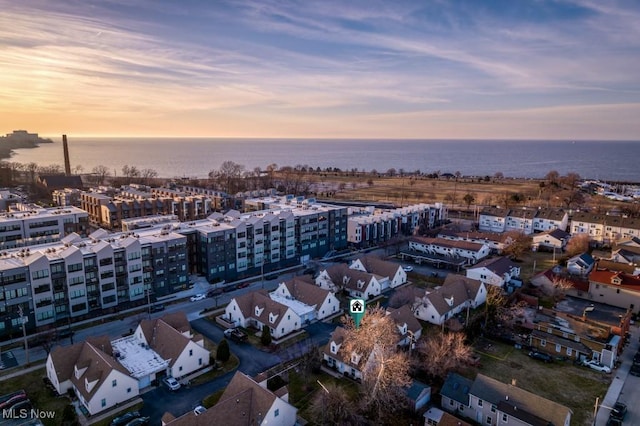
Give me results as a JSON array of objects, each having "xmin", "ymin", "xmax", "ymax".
[{"xmin": 46, "ymin": 313, "xmax": 210, "ymax": 415}]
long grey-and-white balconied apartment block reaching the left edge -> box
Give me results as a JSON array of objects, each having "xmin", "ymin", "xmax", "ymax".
[{"xmin": 0, "ymin": 229, "xmax": 188, "ymax": 335}]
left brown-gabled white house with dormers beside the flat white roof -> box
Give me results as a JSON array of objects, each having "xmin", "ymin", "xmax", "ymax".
[{"xmin": 46, "ymin": 337, "xmax": 139, "ymax": 415}]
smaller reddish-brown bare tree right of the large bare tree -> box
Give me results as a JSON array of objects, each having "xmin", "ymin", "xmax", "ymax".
[{"xmin": 418, "ymin": 332, "xmax": 473, "ymax": 377}]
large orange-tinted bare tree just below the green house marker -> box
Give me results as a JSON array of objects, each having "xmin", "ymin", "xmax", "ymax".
[{"xmin": 343, "ymin": 307, "xmax": 411, "ymax": 416}]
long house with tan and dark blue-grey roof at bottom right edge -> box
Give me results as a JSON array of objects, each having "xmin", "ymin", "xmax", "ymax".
[{"xmin": 440, "ymin": 373, "xmax": 573, "ymax": 426}]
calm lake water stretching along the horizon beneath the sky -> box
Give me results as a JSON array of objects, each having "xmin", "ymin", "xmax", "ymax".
[{"xmin": 6, "ymin": 136, "xmax": 640, "ymax": 182}]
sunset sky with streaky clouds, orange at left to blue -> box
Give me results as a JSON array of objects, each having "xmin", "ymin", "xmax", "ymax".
[{"xmin": 0, "ymin": 0, "xmax": 640, "ymax": 140}]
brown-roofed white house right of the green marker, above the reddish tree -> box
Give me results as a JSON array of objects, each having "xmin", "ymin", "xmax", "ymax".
[{"xmin": 414, "ymin": 274, "xmax": 487, "ymax": 325}]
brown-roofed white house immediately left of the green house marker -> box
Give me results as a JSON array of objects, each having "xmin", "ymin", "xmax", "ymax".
[{"xmin": 270, "ymin": 277, "xmax": 342, "ymax": 324}]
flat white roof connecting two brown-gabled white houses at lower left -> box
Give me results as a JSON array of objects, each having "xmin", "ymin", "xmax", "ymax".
[{"xmin": 111, "ymin": 335, "xmax": 169, "ymax": 379}]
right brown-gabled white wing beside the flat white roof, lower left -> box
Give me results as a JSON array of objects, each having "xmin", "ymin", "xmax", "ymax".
[{"xmin": 134, "ymin": 312, "xmax": 210, "ymax": 377}]
